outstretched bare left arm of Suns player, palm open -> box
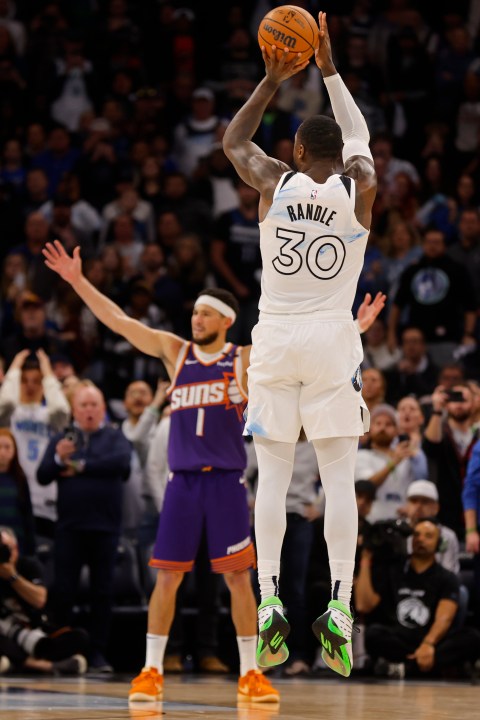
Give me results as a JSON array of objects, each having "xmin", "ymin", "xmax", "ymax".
[{"xmin": 42, "ymin": 240, "xmax": 183, "ymax": 370}]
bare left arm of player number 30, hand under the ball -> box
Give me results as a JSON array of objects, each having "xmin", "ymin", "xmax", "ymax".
[{"xmin": 223, "ymin": 46, "xmax": 309, "ymax": 194}]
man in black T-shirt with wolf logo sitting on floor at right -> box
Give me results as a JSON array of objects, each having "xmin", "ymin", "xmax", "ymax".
[{"xmin": 355, "ymin": 519, "xmax": 480, "ymax": 678}]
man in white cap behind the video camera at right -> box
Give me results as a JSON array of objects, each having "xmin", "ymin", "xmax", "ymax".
[{"xmin": 401, "ymin": 480, "xmax": 460, "ymax": 575}]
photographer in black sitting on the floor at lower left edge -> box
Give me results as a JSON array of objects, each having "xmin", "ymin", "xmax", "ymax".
[{"xmin": 0, "ymin": 527, "xmax": 88, "ymax": 675}]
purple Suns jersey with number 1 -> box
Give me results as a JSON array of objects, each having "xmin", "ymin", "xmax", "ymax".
[{"xmin": 168, "ymin": 343, "xmax": 247, "ymax": 472}]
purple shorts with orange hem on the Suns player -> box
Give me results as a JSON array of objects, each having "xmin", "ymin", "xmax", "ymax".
[{"xmin": 149, "ymin": 470, "xmax": 255, "ymax": 573}]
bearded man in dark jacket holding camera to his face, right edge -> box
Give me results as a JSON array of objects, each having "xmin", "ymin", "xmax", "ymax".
[{"xmin": 422, "ymin": 384, "xmax": 480, "ymax": 541}]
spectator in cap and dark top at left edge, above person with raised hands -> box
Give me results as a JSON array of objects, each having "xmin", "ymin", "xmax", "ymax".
[{"xmin": 1, "ymin": 290, "xmax": 65, "ymax": 366}]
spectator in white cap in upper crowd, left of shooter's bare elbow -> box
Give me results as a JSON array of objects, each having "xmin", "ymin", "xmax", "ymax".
[{"xmin": 172, "ymin": 87, "xmax": 227, "ymax": 178}]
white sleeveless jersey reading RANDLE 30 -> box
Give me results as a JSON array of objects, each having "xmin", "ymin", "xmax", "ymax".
[{"xmin": 259, "ymin": 171, "xmax": 369, "ymax": 315}]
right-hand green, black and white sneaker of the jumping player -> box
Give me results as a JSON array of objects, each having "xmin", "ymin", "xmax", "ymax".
[{"xmin": 312, "ymin": 600, "xmax": 353, "ymax": 677}]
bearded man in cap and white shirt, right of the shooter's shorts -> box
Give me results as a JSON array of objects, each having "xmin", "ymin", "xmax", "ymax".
[{"xmin": 355, "ymin": 403, "xmax": 427, "ymax": 522}]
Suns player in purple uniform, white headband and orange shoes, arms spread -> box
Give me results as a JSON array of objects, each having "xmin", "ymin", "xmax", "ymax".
[{"xmin": 43, "ymin": 240, "xmax": 279, "ymax": 703}]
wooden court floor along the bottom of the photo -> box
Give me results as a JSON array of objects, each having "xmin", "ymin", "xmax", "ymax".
[{"xmin": 0, "ymin": 675, "xmax": 480, "ymax": 720}]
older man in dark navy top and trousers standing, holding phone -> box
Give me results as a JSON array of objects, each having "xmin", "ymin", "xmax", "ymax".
[{"xmin": 37, "ymin": 385, "xmax": 131, "ymax": 672}]
